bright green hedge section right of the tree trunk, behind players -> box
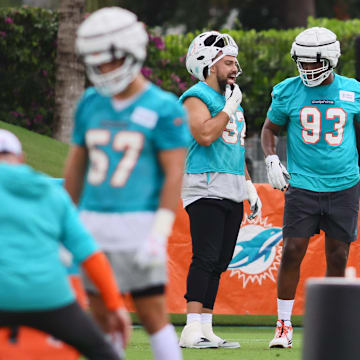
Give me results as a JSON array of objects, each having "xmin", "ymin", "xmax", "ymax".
[{"xmin": 148, "ymin": 18, "xmax": 360, "ymax": 132}]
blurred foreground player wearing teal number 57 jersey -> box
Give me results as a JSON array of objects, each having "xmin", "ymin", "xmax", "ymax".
[{"xmin": 65, "ymin": 7, "xmax": 190, "ymax": 360}]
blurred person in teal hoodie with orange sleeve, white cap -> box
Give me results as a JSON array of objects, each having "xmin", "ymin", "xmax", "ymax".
[{"xmin": 0, "ymin": 129, "xmax": 131, "ymax": 360}]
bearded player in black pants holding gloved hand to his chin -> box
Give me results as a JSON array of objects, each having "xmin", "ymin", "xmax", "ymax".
[{"xmin": 180, "ymin": 31, "xmax": 261, "ymax": 348}]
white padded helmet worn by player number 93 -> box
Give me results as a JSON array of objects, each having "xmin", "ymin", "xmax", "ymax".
[{"xmin": 290, "ymin": 27, "xmax": 341, "ymax": 87}]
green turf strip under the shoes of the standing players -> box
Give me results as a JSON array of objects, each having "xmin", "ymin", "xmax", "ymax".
[{"xmin": 126, "ymin": 326, "xmax": 303, "ymax": 360}]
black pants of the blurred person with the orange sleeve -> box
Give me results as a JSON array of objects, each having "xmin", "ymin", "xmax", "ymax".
[{"xmin": 0, "ymin": 302, "xmax": 120, "ymax": 360}]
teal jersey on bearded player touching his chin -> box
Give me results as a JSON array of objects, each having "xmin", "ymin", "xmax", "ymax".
[{"xmin": 180, "ymin": 82, "xmax": 246, "ymax": 175}]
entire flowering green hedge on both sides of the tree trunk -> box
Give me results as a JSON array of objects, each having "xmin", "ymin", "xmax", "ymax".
[{"xmin": 0, "ymin": 7, "xmax": 360, "ymax": 135}]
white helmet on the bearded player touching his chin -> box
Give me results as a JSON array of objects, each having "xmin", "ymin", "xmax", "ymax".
[{"xmin": 186, "ymin": 31, "xmax": 242, "ymax": 81}]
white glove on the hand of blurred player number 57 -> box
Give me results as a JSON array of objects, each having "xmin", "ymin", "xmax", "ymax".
[{"xmin": 135, "ymin": 234, "xmax": 167, "ymax": 269}]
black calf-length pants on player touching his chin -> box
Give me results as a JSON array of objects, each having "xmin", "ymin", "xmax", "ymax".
[{"xmin": 185, "ymin": 198, "xmax": 243, "ymax": 309}]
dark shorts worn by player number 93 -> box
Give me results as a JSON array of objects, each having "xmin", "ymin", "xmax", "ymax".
[{"xmin": 283, "ymin": 183, "xmax": 360, "ymax": 243}]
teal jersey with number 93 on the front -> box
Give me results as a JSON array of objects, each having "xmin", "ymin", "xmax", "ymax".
[{"xmin": 267, "ymin": 74, "xmax": 360, "ymax": 192}]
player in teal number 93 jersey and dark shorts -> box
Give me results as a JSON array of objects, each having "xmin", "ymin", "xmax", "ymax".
[{"xmin": 261, "ymin": 27, "xmax": 360, "ymax": 348}]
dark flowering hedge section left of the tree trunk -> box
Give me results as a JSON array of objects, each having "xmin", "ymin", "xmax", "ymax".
[{"xmin": 0, "ymin": 8, "xmax": 58, "ymax": 135}]
